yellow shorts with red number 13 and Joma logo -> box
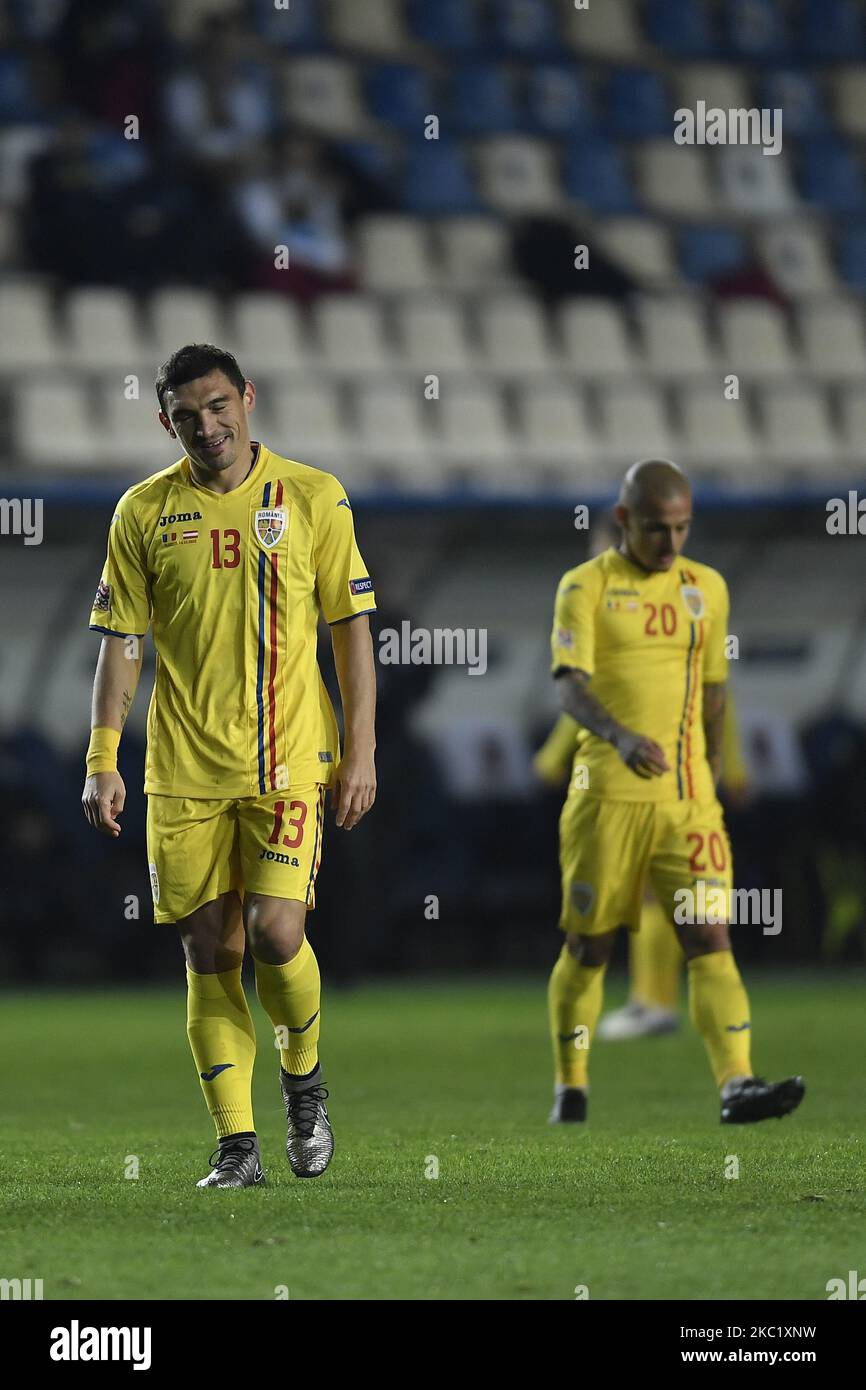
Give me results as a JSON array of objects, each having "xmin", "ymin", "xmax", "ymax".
[{"xmin": 147, "ymin": 783, "xmax": 325, "ymax": 922}]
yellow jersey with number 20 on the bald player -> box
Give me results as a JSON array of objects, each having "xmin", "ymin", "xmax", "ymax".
[{"xmin": 550, "ymin": 549, "xmax": 728, "ymax": 801}]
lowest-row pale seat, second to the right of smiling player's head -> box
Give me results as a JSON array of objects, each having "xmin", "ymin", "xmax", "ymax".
[{"xmin": 352, "ymin": 378, "xmax": 438, "ymax": 488}]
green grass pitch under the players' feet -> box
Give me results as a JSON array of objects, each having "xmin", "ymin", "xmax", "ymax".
[{"xmin": 0, "ymin": 973, "xmax": 866, "ymax": 1300}]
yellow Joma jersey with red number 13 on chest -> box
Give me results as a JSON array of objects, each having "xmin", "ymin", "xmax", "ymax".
[{"xmin": 90, "ymin": 445, "xmax": 375, "ymax": 798}]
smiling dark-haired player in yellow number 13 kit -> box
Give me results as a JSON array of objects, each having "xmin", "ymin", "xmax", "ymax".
[{"xmin": 82, "ymin": 343, "xmax": 375, "ymax": 1187}]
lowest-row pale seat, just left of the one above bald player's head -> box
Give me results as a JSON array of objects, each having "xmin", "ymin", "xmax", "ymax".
[{"xmin": 516, "ymin": 381, "xmax": 598, "ymax": 472}]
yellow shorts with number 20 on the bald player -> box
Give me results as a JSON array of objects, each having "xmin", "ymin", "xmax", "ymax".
[{"xmin": 559, "ymin": 790, "xmax": 734, "ymax": 937}]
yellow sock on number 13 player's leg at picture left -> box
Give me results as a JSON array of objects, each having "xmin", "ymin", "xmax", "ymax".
[{"xmin": 186, "ymin": 966, "xmax": 256, "ymax": 1138}]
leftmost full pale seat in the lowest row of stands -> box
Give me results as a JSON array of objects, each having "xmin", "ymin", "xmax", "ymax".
[{"xmin": 15, "ymin": 377, "xmax": 104, "ymax": 471}]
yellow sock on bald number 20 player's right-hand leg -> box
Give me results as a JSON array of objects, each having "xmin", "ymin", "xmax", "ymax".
[{"xmin": 688, "ymin": 951, "xmax": 752, "ymax": 1087}]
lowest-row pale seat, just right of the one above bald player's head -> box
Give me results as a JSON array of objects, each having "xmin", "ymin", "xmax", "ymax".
[{"xmin": 677, "ymin": 378, "xmax": 760, "ymax": 482}]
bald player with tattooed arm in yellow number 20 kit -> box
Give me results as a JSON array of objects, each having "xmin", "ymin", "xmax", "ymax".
[{"xmin": 549, "ymin": 459, "xmax": 805, "ymax": 1123}]
